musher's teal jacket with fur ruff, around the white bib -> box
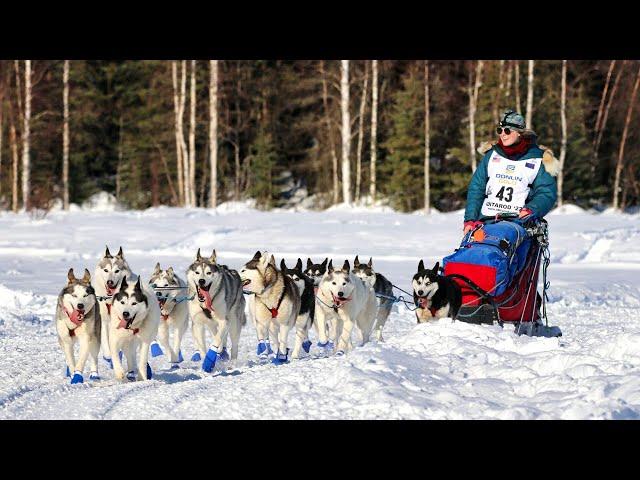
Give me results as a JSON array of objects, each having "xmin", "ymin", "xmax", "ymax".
[{"xmin": 464, "ymin": 135, "xmax": 560, "ymax": 222}]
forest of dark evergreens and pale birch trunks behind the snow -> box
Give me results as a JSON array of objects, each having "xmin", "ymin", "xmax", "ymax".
[{"xmin": 0, "ymin": 60, "xmax": 640, "ymax": 211}]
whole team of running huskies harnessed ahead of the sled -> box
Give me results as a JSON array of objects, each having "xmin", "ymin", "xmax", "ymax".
[{"xmin": 56, "ymin": 247, "xmax": 461, "ymax": 384}]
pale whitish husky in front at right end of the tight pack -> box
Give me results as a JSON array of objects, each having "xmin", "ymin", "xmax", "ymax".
[{"xmin": 315, "ymin": 260, "xmax": 378, "ymax": 355}]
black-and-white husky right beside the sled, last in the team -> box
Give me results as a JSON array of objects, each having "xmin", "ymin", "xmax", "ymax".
[{"xmin": 413, "ymin": 260, "xmax": 462, "ymax": 323}]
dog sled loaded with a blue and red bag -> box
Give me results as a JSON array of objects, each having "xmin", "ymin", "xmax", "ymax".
[{"xmin": 443, "ymin": 214, "xmax": 562, "ymax": 337}]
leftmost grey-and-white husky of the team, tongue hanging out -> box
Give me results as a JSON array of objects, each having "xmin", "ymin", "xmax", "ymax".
[{"xmin": 56, "ymin": 268, "xmax": 102, "ymax": 384}]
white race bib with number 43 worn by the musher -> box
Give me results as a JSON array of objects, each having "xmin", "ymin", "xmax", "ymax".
[{"xmin": 481, "ymin": 151, "xmax": 542, "ymax": 217}]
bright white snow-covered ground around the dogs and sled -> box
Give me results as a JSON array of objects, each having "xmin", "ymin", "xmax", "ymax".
[{"xmin": 0, "ymin": 204, "xmax": 640, "ymax": 419}]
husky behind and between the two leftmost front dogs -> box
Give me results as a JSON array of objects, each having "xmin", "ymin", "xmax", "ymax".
[{"xmin": 93, "ymin": 247, "xmax": 132, "ymax": 368}]
